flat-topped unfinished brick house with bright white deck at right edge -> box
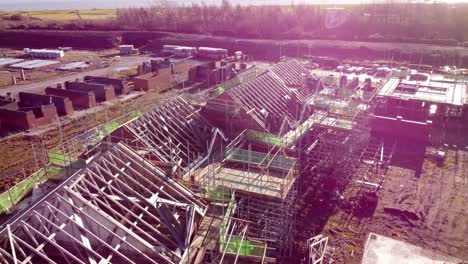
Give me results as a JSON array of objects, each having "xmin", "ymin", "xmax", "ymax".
[{"xmin": 372, "ymin": 79, "xmax": 468, "ymax": 141}]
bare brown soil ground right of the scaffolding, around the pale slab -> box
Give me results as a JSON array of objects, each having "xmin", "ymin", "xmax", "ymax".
[{"xmin": 291, "ymin": 136, "xmax": 468, "ymax": 263}]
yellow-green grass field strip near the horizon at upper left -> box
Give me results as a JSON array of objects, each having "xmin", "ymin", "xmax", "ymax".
[{"xmin": 0, "ymin": 9, "xmax": 117, "ymax": 20}]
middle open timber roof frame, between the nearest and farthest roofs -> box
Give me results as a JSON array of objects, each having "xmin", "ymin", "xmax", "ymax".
[{"xmin": 110, "ymin": 97, "xmax": 227, "ymax": 180}]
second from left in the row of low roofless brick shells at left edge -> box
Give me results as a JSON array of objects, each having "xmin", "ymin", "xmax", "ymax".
[{"xmin": 19, "ymin": 92, "xmax": 74, "ymax": 116}]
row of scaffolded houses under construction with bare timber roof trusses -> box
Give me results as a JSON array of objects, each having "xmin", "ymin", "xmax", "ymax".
[{"xmin": 0, "ymin": 60, "xmax": 462, "ymax": 263}]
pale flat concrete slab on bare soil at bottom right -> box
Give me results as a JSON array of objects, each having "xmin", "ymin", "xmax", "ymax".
[{"xmin": 361, "ymin": 233, "xmax": 462, "ymax": 264}]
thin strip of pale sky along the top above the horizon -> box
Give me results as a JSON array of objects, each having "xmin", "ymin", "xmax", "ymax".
[{"xmin": 0, "ymin": 0, "xmax": 468, "ymax": 10}]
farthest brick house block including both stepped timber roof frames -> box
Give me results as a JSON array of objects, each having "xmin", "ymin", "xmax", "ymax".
[{"xmin": 203, "ymin": 61, "xmax": 312, "ymax": 134}]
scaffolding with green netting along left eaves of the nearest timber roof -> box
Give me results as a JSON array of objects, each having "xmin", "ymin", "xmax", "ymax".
[{"xmin": 0, "ymin": 108, "xmax": 142, "ymax": 214}]
